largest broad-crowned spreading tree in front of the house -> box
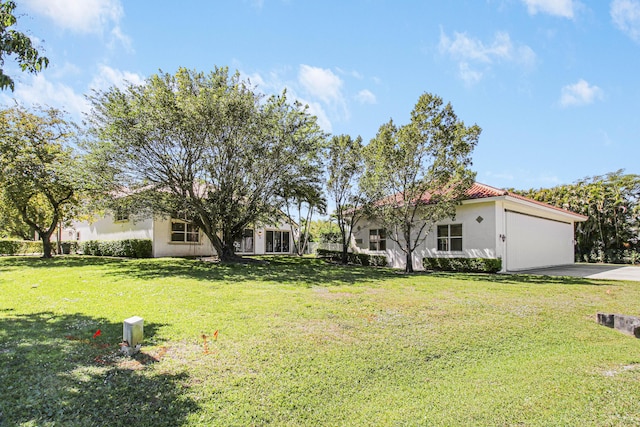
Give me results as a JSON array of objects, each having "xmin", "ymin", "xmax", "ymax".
[{"xmin": 89, "ymin": 68, "xmax": 321, "ymax": 260}]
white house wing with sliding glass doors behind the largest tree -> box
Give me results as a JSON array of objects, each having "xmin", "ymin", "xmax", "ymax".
[{"xmin": 61, "ymin": 211, "xmax": 294, "ymax": 258}]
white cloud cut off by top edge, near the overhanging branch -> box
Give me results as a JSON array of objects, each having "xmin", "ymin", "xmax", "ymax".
[{"xmin": 24, "ymin": 0, "xmax": 124, "ymax": 33}]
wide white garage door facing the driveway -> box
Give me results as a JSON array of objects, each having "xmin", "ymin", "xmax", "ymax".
[{"xmin": 505, "ymin": 211, "xmax": 574, "ymax": 271}]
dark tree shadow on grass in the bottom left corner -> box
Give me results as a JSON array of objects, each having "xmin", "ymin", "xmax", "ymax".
[{"xmin": 0, "ymin": 308, "xmax": 198, "ymax": 426}]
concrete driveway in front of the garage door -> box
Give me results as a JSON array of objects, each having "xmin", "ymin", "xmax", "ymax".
[{"xmin": 514, "ymin": 264, "xmax": 640, "ymax": 282}]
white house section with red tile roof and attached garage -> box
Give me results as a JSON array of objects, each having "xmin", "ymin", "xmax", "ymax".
[{"xmin": 353, "ymin": 183, "xmax": 587, "ymax": 272}]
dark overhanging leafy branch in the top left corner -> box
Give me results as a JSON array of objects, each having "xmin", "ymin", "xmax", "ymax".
[{"xmin": 0, "ymin": 1, "xmax": 49, "ymax": 91}]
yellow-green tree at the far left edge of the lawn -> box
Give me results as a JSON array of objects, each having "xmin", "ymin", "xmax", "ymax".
[{"xmin": 0, "ymin": 107, "xmax": 78, "ymax": 258}]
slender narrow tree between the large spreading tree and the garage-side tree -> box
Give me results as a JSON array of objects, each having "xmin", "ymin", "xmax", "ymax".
[{"xmin": 327, "ymin": 135, "xmax": 365, "ymax": 264}]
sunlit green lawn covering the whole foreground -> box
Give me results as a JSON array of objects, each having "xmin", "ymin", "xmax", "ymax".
[{"xmin": 0, "ymin": 257, "xmax": 640, "ymax": 426}]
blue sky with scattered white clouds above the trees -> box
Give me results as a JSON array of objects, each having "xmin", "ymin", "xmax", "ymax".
[{"xmin": 0, "ymin": 0, "xmax": 640, "ymax": 189}]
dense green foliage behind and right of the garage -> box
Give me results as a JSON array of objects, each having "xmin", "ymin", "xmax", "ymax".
[{"xmin": 519, "ymin": 171, "xmax": 640, "ymax": 263}]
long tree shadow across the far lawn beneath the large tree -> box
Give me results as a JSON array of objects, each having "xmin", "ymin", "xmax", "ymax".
[{"xmin": 0, "ymin": 256, "xmax": 398, "ymax": 287}]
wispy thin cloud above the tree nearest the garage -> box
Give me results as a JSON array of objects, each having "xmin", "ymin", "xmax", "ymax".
[{"xmin": 439, "ymin": 30, "xmax": 536, "ymax": 84}]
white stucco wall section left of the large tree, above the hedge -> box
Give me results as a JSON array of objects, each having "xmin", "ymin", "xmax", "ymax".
[{"xmin": 62, "ymin": 214, "xmax": 153, "ymax": 242}]
